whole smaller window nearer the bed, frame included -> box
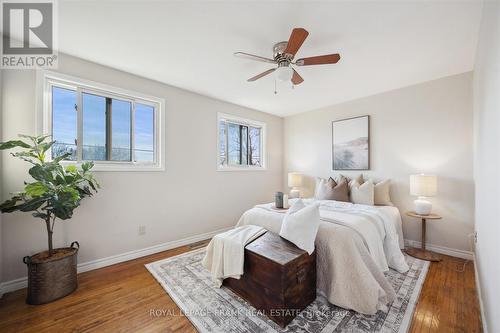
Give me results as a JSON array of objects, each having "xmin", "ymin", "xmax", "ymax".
[{"xmin": 217, "ymin": 113, "xmax": 265, "ymax": 170}]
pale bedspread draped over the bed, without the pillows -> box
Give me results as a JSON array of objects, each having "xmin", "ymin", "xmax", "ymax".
[{"xmin": 237, "ymin": 199, "xmax": 409, "ymax": 314}]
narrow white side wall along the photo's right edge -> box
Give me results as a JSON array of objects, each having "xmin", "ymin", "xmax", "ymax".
[{"xmin": 474, "ymin": 1, "xmax": 500, "ymax": 332}]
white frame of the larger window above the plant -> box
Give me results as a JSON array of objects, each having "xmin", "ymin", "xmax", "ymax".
[{"xmin": 36, "ymin": 71, "xmax": 165, "ymax": 171}]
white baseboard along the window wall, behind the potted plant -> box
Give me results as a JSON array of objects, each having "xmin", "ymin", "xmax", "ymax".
[{"xmin": 0, "ymin": 227, "xmax": 233, "ymax": 297}]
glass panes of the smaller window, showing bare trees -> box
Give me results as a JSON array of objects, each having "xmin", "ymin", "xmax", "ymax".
[{"xmin": 219, "ymin": 119, "xmax": 262, "ymax": 166}]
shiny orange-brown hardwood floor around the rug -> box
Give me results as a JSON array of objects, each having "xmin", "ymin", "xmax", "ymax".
[{"xmin": 0, "ymin": 246, "xmax": 482, "ymax": 333}]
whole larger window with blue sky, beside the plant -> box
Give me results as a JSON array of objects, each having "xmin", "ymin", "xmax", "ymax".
[{"xmin": 43, "ymin": 73, "xmax": 163, "ymax": 170}]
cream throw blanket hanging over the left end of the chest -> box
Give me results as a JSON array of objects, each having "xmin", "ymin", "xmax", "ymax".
[{"xmin": 202, "ymin": 225, "xmax": 266, "ymax": 287}]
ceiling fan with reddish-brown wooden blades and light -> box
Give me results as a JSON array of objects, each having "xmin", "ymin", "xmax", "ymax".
[{"xmin": 234, "ymin": 28, "xmax": 340, "ymax": 85}]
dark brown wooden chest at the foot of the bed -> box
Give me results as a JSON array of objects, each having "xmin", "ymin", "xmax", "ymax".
[{"xmin": 223, "ymin": 232, "xmax": 316, "ymax": 327}]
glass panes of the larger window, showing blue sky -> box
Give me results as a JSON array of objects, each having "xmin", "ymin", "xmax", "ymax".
[{"xmin": 52, "ymin": 86, "xmax": 155, "ymax": 162}]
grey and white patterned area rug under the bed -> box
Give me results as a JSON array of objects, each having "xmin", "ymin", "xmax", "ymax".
[{"xmin": 146, "ymin": 248, "xmax": 429, "ymax": 333}]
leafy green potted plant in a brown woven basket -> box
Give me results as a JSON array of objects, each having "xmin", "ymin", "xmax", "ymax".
[{"xmin": 0, "ymin": 135, "xmax": 99, "ymax": 304}]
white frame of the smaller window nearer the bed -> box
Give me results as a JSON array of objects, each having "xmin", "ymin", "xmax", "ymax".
[{"xmin": 217, "ymin": 112, "xmax": 267, "ymax": 171}]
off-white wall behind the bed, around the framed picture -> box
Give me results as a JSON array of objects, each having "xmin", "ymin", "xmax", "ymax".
[{"xmin": 284, "ymin": 73, "xmax": 474, "ymax": 250}]
